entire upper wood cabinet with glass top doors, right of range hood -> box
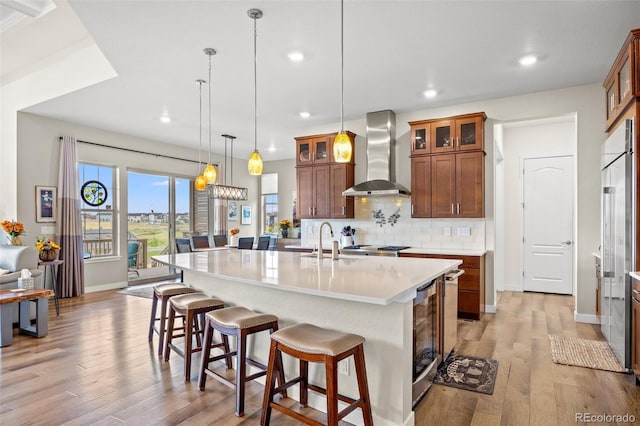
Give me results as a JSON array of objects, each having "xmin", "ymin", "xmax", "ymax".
[{"xmin": 409, "ymin": 112, "xmax": 487, "ymax": 218}]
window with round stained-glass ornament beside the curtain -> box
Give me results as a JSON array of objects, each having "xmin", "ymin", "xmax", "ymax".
[{"xmin": 78, "ymin": 163, "xmax": 117, "ymax": 257}]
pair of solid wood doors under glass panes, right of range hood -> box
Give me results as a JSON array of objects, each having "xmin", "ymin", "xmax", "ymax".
[{"xmin": 431, "ymin": 152, "xmax": 484, "ymax": 218}]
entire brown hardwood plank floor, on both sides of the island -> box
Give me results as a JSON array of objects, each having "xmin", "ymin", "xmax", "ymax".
[{"xmin": 0, "ymin": 291, "xmax": 640, "ymax": 426}]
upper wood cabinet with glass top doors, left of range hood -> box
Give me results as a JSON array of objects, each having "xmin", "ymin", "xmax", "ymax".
[{"xmin": 296, "ymin": 132, "xmax": 356, "ymax": 219}]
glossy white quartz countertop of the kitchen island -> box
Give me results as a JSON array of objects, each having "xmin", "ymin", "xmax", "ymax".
[{"xmin": 153, "ymin": 249, "xmax": 462, "ymax": 305}]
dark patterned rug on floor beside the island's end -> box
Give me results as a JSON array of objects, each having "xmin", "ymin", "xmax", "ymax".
[{"xmin": 433, "ymin": 353, "xmax": 498, "ymax": 395}]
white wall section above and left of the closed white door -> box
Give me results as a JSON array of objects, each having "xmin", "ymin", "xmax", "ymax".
[{"xmin": 503, "ymin": 117, "xmax": 576, "ymax": 291}]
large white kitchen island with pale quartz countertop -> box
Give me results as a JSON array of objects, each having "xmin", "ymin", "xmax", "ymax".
[{"xmin": 153, "ymin": 249, "xmax": 460, "ymax": 425}]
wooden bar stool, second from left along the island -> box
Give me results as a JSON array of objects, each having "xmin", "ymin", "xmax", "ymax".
[{"xmin": 164, "ymin": 293, "xmax": 229, "ymax": 382}]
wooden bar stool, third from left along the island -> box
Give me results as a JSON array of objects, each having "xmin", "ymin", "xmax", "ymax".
[{"xmin": 198, "ymin": 306, "xmax": 286, "ymax": 417}]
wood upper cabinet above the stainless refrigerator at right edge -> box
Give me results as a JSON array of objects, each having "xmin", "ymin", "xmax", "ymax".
[{"xmin": 604, "ymin": 29, "xmax": 640, "ymax": 131}]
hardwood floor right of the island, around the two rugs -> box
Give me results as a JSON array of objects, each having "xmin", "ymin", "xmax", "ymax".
[{"xmin": 416, "ymin": 292, "xmax": 640, "ymax": 426}]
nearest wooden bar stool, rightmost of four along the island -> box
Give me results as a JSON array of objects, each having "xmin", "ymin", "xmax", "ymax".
[{"xmin": 260, "ymin": 324, "xmax": 373, "ymax": 426}]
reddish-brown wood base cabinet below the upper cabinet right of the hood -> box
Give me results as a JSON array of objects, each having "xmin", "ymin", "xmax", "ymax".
[{"xmin": 400, "ymin": 253, "xmax": 485, "ymax": 320}]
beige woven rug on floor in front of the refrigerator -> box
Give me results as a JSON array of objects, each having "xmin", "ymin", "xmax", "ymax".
[{"xmin": 549, "ymin": 334, "xmax": 625, "ymax": 373}]
